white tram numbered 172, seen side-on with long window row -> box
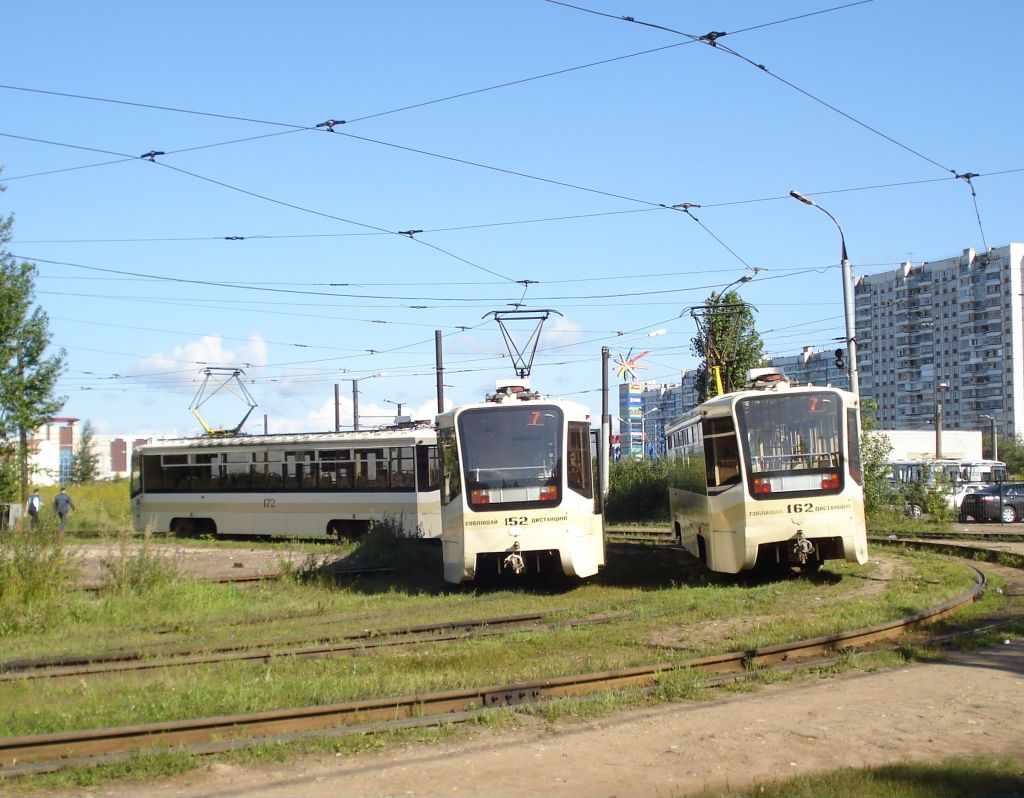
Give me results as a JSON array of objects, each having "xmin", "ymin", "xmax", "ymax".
[{"xmin": 131, "ymin": 424, "xmax": 440, "ymax": 538}]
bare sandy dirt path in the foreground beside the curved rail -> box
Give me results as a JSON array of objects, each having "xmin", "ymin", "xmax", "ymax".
[{"xmin": 61, "ymin": 640, "xmax": 1024, "ymax": 798}]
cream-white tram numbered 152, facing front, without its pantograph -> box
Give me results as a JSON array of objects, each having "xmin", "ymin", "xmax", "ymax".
[{"xmin": 437, "ymin": 388, "xmax": 604, "ymax": 583}]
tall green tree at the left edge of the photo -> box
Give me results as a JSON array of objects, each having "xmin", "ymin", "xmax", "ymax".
[{"xmin": 0, "ymin": 181, "xmax": 66, "ymax": 503}]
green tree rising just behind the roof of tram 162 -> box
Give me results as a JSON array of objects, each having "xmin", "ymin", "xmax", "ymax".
[{"xmin": 690, "ymin": 291, "xmax": 764, "ymax": 402}]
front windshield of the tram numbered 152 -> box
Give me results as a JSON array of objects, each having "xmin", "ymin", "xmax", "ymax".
[{"xmin": 459, "ymin": 405, "xmax": 563, "ymax": 510}]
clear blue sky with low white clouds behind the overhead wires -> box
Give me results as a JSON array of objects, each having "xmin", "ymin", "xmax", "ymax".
[{"xmin": 0, "ymin": 0, "xmax": 1024, "ymax": 434}]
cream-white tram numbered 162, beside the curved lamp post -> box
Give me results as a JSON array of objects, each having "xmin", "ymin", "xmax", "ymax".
[{"xmin": 666, "ymin": 370, "xmax": 867, "ymax": 574}]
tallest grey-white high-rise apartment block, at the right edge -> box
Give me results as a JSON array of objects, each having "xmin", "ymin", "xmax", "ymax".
[{"xmin": 854, "ymin": 244, "xmax": 1024, "ymax": 435}]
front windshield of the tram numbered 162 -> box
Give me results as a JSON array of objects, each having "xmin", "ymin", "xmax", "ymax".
[{"xmin": 736, "ymin": 391, "xmax": 844, "ymax": 498}]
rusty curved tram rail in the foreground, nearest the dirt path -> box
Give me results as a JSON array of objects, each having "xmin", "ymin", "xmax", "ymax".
[{"xmin": 0, "ymin": 565, "xmax": 985, "ymax": 775}]
